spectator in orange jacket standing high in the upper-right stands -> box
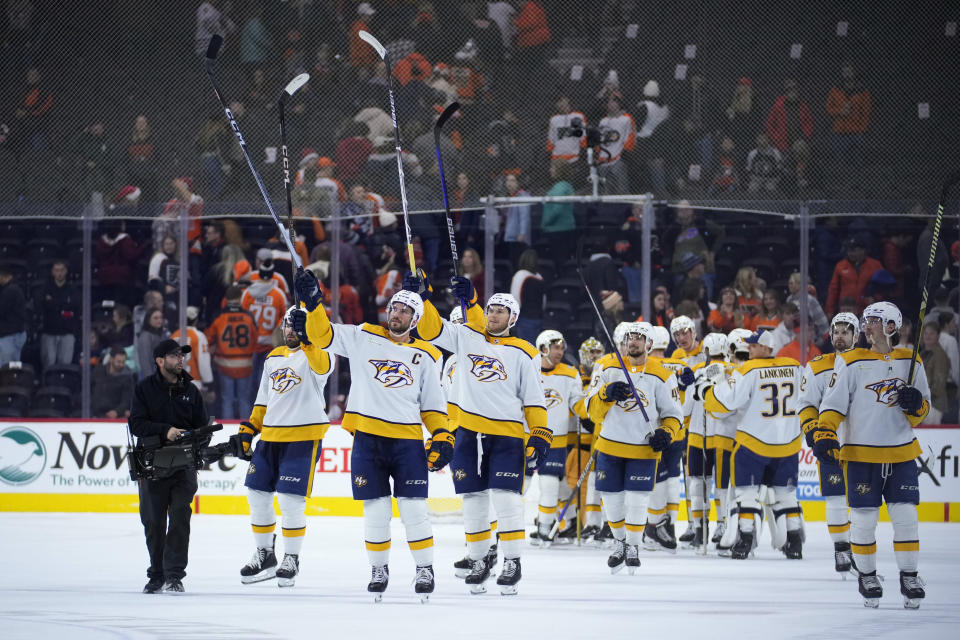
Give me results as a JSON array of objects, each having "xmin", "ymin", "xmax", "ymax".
[{"xmin": 827, "ymin": 62, "xmax": 873, "ymax": 167}]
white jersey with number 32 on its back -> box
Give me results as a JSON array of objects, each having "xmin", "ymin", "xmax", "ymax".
[{"xmin": 705, "ymin": 358, "xmax": 801, "ymax": 458}]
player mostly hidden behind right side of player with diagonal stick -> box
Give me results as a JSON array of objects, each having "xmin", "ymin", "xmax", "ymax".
[{"xmin": 643, "ymin": 323, "xmax": 692, "ymax": 553}]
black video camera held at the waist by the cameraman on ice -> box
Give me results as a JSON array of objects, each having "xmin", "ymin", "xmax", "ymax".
[{"xmin": 127, "ymin": 424, "xmax": 243, "ymax": 480}]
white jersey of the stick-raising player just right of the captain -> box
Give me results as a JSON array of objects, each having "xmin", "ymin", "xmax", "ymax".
[{"xmin": 417, "ymin": 301, "xmax": 547, "ymax": 438}]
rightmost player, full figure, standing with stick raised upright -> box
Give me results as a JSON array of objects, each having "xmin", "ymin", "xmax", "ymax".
[{"xmin": 812, "ymin": 302, "xmax": 930, "ymax": 609}]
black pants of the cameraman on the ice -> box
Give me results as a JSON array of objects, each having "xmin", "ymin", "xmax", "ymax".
[{"xmin": 140, "ymin": 471, "xmax": 197, "ymax": 580}]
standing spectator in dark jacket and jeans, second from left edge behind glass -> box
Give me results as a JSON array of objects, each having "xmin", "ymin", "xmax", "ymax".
[{"xmin": 37, "ymin": 260, "xmax": 81, "ymax": 369}]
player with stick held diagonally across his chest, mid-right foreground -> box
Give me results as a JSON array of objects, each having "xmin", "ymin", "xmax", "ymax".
[{"xmin": 588, "ymin": 323, "xmax": 682, "ymax": 573}]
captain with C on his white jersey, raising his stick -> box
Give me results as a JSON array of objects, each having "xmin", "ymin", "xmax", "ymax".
[{"xmin": 295, "ymin": 270, "xmax": 454, "ymax": 601}]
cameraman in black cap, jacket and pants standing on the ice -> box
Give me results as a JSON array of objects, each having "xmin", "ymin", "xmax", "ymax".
[{"xmin": 129, "ymin": 339, "xmax": 208, "ymax": 593}]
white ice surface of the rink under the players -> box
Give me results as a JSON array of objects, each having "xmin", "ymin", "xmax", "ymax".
[{"xmin": 0, "ymin": 513, "xmax": 960, "ymax": 640}]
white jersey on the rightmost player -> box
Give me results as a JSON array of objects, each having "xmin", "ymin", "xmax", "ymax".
[{"xmin": 819, "ymin": 349, "xmax": 930, "ymax": 463}]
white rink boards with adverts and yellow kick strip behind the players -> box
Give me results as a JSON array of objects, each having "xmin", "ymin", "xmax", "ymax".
[{"xmin": 0, "ymin": 419, "xmax": 960, "ymax": 522}]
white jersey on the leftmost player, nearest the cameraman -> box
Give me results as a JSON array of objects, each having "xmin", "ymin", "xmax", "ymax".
[{"xmin": 249, "ymin": 345, "xmax": 332, "ymax": 442}]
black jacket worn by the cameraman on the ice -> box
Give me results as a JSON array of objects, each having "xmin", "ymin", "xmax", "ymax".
[{"xmin": 129, "ymin": 371, "xmax": 209, "ymax": 438}]
